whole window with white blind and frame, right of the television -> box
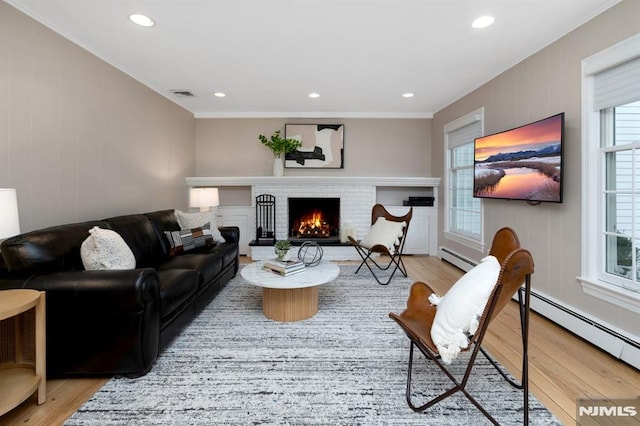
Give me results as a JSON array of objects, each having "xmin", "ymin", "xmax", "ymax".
[{"xmin": 579, "ymin": 31, "xmax": 640, "ymax": 311}]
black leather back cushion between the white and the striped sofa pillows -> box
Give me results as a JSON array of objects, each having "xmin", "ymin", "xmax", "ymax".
[{"xmin": 104, "ymin": 214, "xmax": 165, "ymax": 268}]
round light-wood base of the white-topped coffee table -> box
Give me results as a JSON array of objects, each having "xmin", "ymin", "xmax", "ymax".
[{"xmin": 262, "ymin": 286, "xmax": 318, "ymax": 322}]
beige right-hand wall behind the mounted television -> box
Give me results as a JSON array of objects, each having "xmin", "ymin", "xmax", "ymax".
[{"xmin": 431, "ymin": 0, "xmax": 640, "ymax": 335}]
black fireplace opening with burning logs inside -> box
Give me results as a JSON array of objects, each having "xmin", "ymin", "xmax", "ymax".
[{"xmin": 288, "ymin": 197, "xmax": 340, "ymax": 242}]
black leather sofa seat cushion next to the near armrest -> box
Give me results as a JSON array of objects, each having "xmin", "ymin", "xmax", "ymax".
[{"xmin": 158, "ymin": 269, "xmax": 198, "ymax": 321}]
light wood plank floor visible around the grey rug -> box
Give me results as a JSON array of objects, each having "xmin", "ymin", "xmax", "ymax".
[{"xmin": 0, "ymin": 256, "xmax": 640, "ymax": 426}]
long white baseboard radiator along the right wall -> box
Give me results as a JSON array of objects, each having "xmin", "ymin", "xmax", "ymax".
[{"xmin": 440, "ymin": 247, "xmax": 640, "ymax": 369}]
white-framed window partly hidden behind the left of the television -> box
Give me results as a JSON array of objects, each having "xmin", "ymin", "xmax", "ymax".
[{"xmin": 444, "ymin": 109, "xmax": 484, "ymax": 249}]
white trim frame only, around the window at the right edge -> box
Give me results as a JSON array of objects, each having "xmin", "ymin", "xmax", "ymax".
[{"xmin": 577, "ymin": 34, "xmax": 640, "ymax": 312}]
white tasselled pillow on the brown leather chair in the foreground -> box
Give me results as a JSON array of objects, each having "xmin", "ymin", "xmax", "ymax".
[{"xmin": 429, "ymin": 256, "xmax": 500, "ymax": 364}]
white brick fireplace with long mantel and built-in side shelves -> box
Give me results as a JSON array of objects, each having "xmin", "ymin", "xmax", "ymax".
[{"xmin": 186, "ymin": 176, "xmax": 440, "ymax": 260}]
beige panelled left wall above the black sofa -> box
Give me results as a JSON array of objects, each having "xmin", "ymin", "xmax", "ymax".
[{"xmin": 0, "ymin": 2, "xmax": 195, "ymax": 232}]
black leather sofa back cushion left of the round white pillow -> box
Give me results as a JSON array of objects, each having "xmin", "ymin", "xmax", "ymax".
[{"xmin": 1, "ymin": 221, "xmax": 105, "ymax": 273}]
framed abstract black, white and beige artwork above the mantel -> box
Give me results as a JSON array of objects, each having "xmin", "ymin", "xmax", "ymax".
[{"xmin": 284, "ymin": 124, "xmax": 344, "ymax": 169}]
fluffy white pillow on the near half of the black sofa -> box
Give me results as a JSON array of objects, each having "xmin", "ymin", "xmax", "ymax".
[{"xmin": 80, "ymin": 226, "xmax": 136, "ymax": 271}]
